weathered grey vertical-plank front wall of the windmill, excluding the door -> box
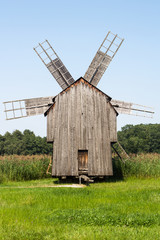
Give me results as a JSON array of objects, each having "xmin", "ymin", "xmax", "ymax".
[{"xmin": 47, "ymin": 80, "xmax": 116, "ymax": 176}]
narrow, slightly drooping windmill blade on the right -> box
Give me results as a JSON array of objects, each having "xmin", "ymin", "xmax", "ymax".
[{"xmin": 111, "ymin": 99, "xmax": 154, "ymax": 118}]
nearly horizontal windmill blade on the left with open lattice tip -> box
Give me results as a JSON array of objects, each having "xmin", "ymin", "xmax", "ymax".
[{"xmin": 4, "ymin": 97, "xmax": 54, "ymax": 120}]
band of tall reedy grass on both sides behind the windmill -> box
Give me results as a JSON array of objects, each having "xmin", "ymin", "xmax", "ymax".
[{"xmin": 0, "ymin": 153, "xmax": 160, "ymax": 183}]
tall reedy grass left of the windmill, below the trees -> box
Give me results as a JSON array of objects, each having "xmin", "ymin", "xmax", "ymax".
[{"xmin": 0, "ymin": 155, "xmax": 49, "ymax": 183}]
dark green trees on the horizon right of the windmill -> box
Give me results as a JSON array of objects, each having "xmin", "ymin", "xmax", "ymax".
[{"xmin": 118, "ymin": 124, "xmax": 160, "ymax": 154}]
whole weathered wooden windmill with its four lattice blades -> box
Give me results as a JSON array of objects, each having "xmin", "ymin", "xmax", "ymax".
[{"xmin": 4, "ymin": 32, "xmax": 153, "ymax": 177}]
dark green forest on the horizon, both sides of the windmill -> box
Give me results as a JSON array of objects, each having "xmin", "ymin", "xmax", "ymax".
[{"xmin": 0, "ymin": 124, "xmax": 160, "ymax": 156}]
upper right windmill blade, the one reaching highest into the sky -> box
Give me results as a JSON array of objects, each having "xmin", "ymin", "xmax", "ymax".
[{"xmin": 84, "ymin": 31, "xmax": 124, "ymax": 86}]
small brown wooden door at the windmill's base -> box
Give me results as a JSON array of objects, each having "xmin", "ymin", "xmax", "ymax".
[{"xmin": 78, "ymin": 150, "xmax": 88, "ymax": 173}]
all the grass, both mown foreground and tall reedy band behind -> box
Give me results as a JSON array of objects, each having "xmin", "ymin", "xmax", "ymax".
[{"xmin": 0, "ymin": 154, "xmax": 160, "ymax": 240}]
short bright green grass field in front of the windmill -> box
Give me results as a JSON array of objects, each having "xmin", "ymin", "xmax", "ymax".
[{"xmin": 0, "ymin": 178, "xmax": 160, "ymax": 240}]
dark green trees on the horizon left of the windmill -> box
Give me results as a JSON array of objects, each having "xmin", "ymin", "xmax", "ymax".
[{"xmin": 0, "ymin": 130, "xmax": 53, "ymax": 155}]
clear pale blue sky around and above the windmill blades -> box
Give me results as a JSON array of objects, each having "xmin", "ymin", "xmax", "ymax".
[{"xmin": 0, "ymin": 0, "xmax": 160, "ymax": 137}]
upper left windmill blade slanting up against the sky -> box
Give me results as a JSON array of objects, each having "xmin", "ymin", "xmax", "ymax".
[{"xmin": 33, "ymin": 40, "xmax": 74, "ymax": 89}]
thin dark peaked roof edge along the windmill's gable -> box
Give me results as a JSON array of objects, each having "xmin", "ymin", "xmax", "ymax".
[{"xmin": 44, "ymin": 77, "xmax": 118, "ymax": 116}]
